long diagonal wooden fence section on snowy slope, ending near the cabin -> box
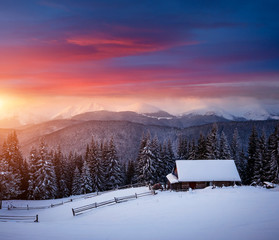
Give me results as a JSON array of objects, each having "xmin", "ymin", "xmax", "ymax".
[{"xmin": 72, "ymin": 190, "xmax": 156, "ymax": 216}]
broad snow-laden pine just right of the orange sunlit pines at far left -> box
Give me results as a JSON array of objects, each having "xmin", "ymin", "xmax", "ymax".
[{"xmin": 34, "ymin": 140, "xmax": 57, "ymax": 199}]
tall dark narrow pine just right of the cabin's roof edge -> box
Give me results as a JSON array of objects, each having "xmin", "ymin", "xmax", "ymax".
[{"xmin": 247, "ymin": 126, "xmax": 262, "ymax": 184}]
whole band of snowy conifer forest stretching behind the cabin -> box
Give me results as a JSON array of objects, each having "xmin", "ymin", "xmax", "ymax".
[{"xmin": 0, "ymin": 124, "xmax": 279, "ymax": 200}]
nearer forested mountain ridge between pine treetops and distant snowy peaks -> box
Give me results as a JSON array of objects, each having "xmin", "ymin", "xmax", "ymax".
[{"xmin": 0, "ymin": 110, "xmax": 279, "ymax": 161}]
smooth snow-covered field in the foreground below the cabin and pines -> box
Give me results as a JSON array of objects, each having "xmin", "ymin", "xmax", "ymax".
[{"xmin": 0, "ymin": 186, "xmax": 279, "ymax": 240}]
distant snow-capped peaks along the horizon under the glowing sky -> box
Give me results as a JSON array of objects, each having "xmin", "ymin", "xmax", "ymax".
[{"xmin": 0, "ymin": 102, "xmax": 279, "ymax": 128}]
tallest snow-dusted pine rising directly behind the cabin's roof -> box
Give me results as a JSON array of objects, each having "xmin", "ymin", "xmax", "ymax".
[{"xmin": 206, "ymin": 124, "xmax": 220, "ymax": 159}]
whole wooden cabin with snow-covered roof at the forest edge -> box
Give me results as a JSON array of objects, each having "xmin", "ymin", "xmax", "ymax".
[{"xmin": 167, "ymin": 160, "xmax": 241, "ymax": 190}]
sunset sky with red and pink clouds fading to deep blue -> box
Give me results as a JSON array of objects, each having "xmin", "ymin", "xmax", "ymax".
[{"xmin": 0, "ymin": 0, "xmax": 279, "ymax": 120}]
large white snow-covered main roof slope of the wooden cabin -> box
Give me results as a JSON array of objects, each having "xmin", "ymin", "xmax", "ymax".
[{"xmin": 176, "ymin": 160, "xmax": 241, "ymax": 182}]
